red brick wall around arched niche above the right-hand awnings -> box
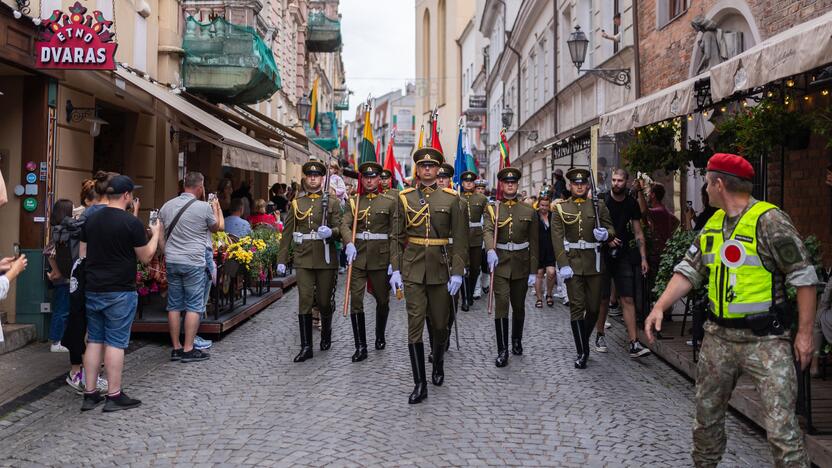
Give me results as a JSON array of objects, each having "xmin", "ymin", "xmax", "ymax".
[{"xmin": 638, "ymin": 0, "xmax": 832, "ymax": 96}]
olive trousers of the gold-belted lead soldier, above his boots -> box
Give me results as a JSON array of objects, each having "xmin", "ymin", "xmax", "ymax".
[{"xmin": 404, "ymin": 281, "xmax": 451, "ymax": 346}]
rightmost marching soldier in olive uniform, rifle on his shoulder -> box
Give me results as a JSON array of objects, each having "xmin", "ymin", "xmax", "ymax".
[{"xmin": 552, "ymin": 169, "xmax": 615, "ymax": 369}]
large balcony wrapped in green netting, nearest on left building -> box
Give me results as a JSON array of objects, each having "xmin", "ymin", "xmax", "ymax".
[{"xmin": 182, "ymin": 17, "xmax": 281, "ymax": 104}]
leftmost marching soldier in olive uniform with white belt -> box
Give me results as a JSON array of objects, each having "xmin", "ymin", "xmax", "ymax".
[{"xmin": 277, "ymin": 161, "xmax": 341, "ymax": 362}]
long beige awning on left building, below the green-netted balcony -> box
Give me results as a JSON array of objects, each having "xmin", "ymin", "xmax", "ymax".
[{"xmin": 116, "ymin": 66, "xmax": 279, "ymax": 174}]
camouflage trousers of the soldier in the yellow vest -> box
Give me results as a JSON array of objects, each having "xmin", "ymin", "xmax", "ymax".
[{"xmin": 692, "ymin": 321, "xmax": 809, "ymax": 467}]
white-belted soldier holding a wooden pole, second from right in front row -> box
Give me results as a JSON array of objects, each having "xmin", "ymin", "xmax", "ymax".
[{"xmin": 483, "ymin": 167, "xmax": 536, "ymax": 367}]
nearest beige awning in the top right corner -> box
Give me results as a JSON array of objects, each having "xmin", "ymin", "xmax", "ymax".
[{"xmin": 711, "ymin": 12, "xmax": 832, "ymax": 102}]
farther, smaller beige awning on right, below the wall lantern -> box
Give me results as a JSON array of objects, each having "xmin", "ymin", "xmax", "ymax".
[{"xmin": 600, "ymin": 72, "xmax": 708, "ymax": 135}]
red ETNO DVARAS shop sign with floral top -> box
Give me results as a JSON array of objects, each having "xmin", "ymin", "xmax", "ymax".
[{"xmin": 35, "ymin": 2, "xmax": 118, "ymax": 70}]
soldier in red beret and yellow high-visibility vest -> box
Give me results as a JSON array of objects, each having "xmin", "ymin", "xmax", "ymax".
[{"xmin": 644, "ymin": 154, "xmax": 818, "ymax": 467}]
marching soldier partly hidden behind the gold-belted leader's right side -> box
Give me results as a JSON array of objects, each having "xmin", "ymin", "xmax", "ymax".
[{"xmin": 460, "ymin": 171, "xmax": 488, "ymax": 311}]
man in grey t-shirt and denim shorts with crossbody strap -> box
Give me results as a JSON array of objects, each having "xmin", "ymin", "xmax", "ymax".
[{"xmin": 159, "ymin": 172, "xmax": 224, "ymax": 362}]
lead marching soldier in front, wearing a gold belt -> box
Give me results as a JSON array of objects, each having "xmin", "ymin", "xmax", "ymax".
[{"xmin": 393, "ymin": 148, "xmax": 468, "ymax": 404}]
